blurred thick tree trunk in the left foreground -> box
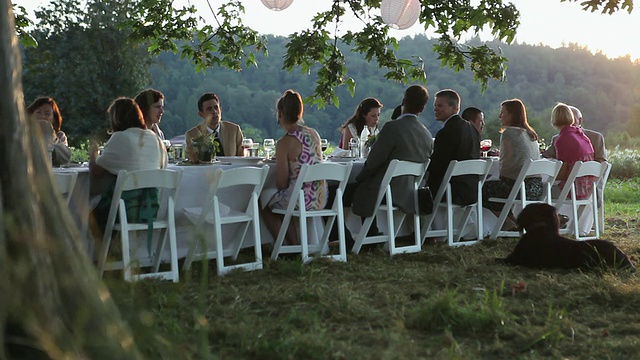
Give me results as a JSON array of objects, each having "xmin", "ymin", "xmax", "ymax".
[{"xmin": 0, "ymin": 0, "xmax": 142, "ymax": 359}]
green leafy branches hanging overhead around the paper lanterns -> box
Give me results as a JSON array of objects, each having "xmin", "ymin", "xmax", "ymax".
[{"xmin": 12, "ymin": 0, "xmax": 633, "ymax": 107}]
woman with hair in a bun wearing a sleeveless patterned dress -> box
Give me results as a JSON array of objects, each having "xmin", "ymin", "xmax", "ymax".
[{"xmin": 262, "ymin": 90, "xmax": 328, "ymax": 245}]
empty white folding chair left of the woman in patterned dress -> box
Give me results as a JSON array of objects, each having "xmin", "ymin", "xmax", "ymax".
[{"xmin": 183, "ymin": 165, "xmax": 269, "ymax": 276}]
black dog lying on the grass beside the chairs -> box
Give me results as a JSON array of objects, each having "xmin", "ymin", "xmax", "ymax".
[{"xmin": 496, "ymin": 203, "xmax": 636, "ymax": 272}]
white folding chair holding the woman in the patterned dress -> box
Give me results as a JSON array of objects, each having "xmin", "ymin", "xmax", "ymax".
[{"xmin": 271, "ymin": 163, "xmax": 353, "ymax": 264}]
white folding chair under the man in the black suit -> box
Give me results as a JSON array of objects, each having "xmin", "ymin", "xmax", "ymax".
[{"xmin": 421, "ymin": 160, "xmax": 493, "ymax": 246}]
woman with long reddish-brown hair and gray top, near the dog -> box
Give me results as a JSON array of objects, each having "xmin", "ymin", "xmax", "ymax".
[{"xmin": 482, "ymin": 99, "xmax": 542, "ymax": 222}]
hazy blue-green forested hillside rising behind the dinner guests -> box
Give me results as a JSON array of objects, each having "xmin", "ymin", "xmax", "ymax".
[{"xmin": 151, "ymin": 36, "xmax": 640, "ymax": 143}]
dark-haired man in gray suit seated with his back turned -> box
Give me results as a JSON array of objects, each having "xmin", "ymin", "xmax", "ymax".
[{"xmin": 345, "ymin": 85, "xmax": 433, "ymax": 217}]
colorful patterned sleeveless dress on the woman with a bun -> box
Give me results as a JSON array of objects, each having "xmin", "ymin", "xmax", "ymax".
[{"xmin": 269, "ymin": 127, "xmax": 328, "ymax": 210}]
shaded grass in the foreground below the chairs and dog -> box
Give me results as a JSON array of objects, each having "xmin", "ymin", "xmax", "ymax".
[{"xmin": 106, "ymin": 203, "xmax": 640, "ymax": 359}]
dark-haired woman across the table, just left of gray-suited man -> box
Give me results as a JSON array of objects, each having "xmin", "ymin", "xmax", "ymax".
[{"xmin": 338, "ymin": 98, "xmax": 382, "ymax": 150}]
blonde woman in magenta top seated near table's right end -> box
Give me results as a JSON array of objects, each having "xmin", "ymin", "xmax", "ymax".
[{"xmin": 551, "ymin": 103, "xmax": 594, "ymax": 200}]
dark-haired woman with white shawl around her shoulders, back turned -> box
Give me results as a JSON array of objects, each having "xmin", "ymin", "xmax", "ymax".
[{"xmin": 89, "ymin": 97, "xmax": 167, "ymax": 231}]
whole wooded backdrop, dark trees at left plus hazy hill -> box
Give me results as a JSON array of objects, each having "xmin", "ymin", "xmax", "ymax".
[{"xmin": 23, "ymin": 32, "xmax": 640, "ymax": 148}]
